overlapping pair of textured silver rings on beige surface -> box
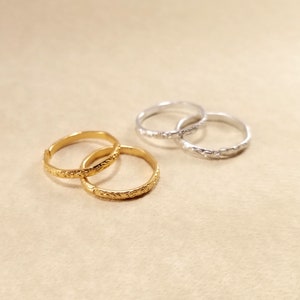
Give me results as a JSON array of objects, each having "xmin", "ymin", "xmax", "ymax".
[{"xmin": 136, "ymin": 101, "xmax": 251, "ymax": 159}]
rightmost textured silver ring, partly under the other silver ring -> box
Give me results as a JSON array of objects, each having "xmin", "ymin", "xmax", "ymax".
[{"xmin": 176, "ymin": 113, "xmax": 251, "ymax": 159}]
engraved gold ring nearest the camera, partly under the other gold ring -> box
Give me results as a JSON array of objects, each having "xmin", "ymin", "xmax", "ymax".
[{"xmin": 81, "ymin": 145, "xmax": 160, "ymax": 200}]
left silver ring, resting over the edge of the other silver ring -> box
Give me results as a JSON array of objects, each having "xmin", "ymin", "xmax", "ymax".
[{"xmin": 136, "ymin": 102, "xmax": 206, "ymax": 139}]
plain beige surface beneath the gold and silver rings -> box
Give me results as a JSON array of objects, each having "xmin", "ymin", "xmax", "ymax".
[{"xmin": 0, "ymin": 0, "xmax": 300, "ymax": 300}]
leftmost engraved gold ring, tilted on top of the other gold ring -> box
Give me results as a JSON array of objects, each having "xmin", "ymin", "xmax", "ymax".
[{"xmin": 44, "ymin": 131, "xmax": 120, "ymax": 178}]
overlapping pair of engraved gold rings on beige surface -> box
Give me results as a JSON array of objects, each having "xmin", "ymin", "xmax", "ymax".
[{"xmin": 44, "ymin": 131, "xmax": 160, "ymax": 200}]
